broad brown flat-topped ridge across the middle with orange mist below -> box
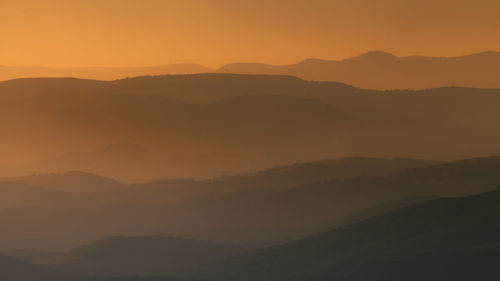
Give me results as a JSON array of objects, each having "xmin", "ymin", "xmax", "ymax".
[{"xmin": 0, "ymin": 74, "xmax": 500, "ymax": 182}]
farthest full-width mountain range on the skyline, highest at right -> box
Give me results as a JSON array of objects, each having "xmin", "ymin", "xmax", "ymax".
[{"xmin": 0, "ymin": 51, "xmax": 500, "ymax": 90}]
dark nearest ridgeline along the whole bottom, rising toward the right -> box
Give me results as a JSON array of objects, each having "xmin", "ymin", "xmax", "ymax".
[{"xmin": 0, "ymin": 191, "xmax": 500, "ymax": 281}]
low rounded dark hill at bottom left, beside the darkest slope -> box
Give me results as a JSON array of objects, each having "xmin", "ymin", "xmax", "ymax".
[{"xmin": 47, "ymin": 236, "xmax": 242, "ymax": 277}]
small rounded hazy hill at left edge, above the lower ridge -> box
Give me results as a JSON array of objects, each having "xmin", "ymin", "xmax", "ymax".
[{"xmin": 0, "ymin": 171, "xmax": 122, "ymax": 192}]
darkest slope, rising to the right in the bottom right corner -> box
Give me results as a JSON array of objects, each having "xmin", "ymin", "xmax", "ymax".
[{"xmin": 187, "ymin": 192, "xmax": 500, "ymax": 281}]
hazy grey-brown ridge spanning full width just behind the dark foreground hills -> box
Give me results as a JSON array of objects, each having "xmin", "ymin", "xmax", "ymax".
[{"xmin": 0, "ymin": 155, "xmax": 500, "ymax": 250}]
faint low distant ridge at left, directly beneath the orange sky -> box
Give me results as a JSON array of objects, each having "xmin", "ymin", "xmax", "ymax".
[{"xmin": 0, "ymin": 64, "xmax": 212, "ymax": 81}]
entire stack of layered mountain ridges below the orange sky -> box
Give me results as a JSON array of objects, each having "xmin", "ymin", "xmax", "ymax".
[{"xmin": 0, "ymin": 52, "xmax": 500, "ymax": 281}]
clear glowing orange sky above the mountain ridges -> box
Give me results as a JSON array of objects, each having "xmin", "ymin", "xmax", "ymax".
[{"xmin": 0, "ymin": 0, "xmax": 500, "ymax": 67}]
